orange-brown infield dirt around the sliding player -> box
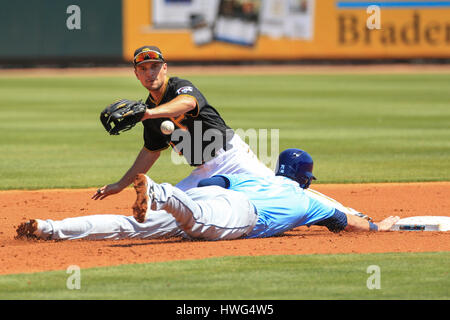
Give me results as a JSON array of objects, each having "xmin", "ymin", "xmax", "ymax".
[{"xmin": 0, "ymin": 182, "xmax": 450, "ymax": 274}]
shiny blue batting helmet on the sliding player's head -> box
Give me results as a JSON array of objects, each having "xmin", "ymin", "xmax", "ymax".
[{"xmin": 275, "ymin": 148, "xmax": 316, "ymax": 189}]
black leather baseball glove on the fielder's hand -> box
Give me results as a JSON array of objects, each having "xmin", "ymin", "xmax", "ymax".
[{"xmin": 100, "ymin": 99, "xmax": 147, "ymax": 135}]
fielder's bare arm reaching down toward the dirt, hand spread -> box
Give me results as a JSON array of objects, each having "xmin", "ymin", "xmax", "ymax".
[{"xmin": 92, "ymin": 148, "xmax": 160, "ymax": 200}]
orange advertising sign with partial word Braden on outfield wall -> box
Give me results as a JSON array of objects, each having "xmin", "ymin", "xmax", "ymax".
[{"xmin": 123, "ymin": 0, "xmax": 450, "ymax": 61}]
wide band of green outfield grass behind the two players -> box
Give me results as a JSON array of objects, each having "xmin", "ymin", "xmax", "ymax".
[{"xmin": 0, "ymin": 74, "xmax": 450, "ymax": 189}]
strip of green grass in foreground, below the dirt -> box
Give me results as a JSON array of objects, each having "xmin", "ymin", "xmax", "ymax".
[{"xmin": 0, "ymin": 252, "xmax": 450, "ymax": 300}]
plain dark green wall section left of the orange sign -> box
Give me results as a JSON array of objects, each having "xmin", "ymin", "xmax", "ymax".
[{"xmin": 0, "ymin": 0, "xmax": 122, "ymax": 61}]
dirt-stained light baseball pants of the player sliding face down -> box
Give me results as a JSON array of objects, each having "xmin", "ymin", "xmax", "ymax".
[{"xmin": 38, "ymin": 183, "xmax": 258, "ymax": 240}]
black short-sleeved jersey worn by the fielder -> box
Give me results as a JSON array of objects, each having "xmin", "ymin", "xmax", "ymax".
[{"xmin": 142, "ymin": 77, "xmax": 234, "ymax": 166}]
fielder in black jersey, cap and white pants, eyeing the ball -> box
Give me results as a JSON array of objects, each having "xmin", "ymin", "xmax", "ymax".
[{"xmin": 92, "ymin": 46, "xmax": 273, "ymax": 200}]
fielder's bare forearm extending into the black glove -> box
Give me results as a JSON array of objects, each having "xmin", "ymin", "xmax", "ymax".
[{"xmin": 142, "ymin": 95, "xmax": 197, "ymax": 121}]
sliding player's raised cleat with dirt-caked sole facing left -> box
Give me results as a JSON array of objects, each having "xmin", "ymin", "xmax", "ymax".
[{"xmin": 133, "ymin": 173, "xmax": 154, "ymax": 223}]
